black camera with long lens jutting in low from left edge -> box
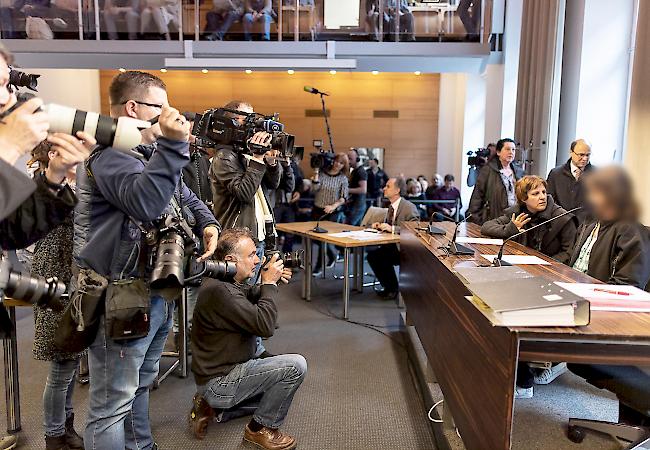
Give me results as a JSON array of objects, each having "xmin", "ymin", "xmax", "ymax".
[{"xmin": 0, "ymin": 258, "xmax": 65, "ymax": 336}]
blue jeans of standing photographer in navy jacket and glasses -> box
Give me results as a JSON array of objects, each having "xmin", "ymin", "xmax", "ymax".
[{"xmin": 84, "ymin": 296, "xmax": 174, "ymax": 450}]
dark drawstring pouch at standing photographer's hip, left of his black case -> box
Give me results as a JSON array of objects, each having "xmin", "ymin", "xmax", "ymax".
[{"xmin": 54, "ymin": 266, "xmax": 108, "ymax": 353}]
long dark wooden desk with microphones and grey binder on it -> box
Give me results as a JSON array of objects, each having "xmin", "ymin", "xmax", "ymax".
[{"xmin": 400, "ymin": 222, "xmax": 650, "ymax": 450}]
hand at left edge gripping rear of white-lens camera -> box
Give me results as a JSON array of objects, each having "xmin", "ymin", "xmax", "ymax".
[{"xmin": 0, "ymin": 98, "xmax": 50, "ymax": 165}]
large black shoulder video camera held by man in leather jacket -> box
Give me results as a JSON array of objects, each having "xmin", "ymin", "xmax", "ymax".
[{"xmin": 192, "ymin": 108, "xmax": 295, "ymax": 158}]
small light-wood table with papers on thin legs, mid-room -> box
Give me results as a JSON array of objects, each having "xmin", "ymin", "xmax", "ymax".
[{"xmin": 276, "ymin": 221, "xmax": 400, "ymax": 320}]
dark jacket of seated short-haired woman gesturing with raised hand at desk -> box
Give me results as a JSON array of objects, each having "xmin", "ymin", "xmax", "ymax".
[{"xmin": 481, "ymin": 195, "xmax": 578, "ymax": 264}]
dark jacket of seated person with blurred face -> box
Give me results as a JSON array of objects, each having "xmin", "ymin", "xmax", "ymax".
[{"xmin": 569, "ymin": 221, "xmax": 650, "ymax": 289}]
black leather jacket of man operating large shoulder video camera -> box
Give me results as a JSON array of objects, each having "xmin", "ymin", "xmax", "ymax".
[{"xmin": 210, "ymin": 145, "xmax": 282, "ymax": 237}]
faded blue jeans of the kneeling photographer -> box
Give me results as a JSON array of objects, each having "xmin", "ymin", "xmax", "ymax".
[{"xmin": 198, "ymin": 355, "xmax": 307, "ymax": 429}]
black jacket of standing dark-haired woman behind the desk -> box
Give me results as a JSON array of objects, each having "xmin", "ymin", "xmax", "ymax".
[{"xmin": 467, "ymin": 158, "xmax": 522, "ymax": 225}]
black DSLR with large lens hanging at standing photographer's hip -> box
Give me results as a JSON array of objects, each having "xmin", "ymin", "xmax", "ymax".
[{"xmin": 146, "ymin": 216, "xmax": 237, "ymax": 289}]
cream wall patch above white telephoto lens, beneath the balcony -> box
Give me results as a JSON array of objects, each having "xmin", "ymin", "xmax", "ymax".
[{"xmin": 27, "ymin": 69, "xmax": 101, "ymax": 112}]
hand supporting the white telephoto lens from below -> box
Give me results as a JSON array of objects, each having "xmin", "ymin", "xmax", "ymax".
[{"xmin": 45, "ymin": 131, "xmax": 97, "ymax": 184}]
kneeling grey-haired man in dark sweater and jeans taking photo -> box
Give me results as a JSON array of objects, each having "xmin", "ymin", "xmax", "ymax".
[{"xmin": 190, "ymin": 228, "xmax": 307, "ymax": 450}]
